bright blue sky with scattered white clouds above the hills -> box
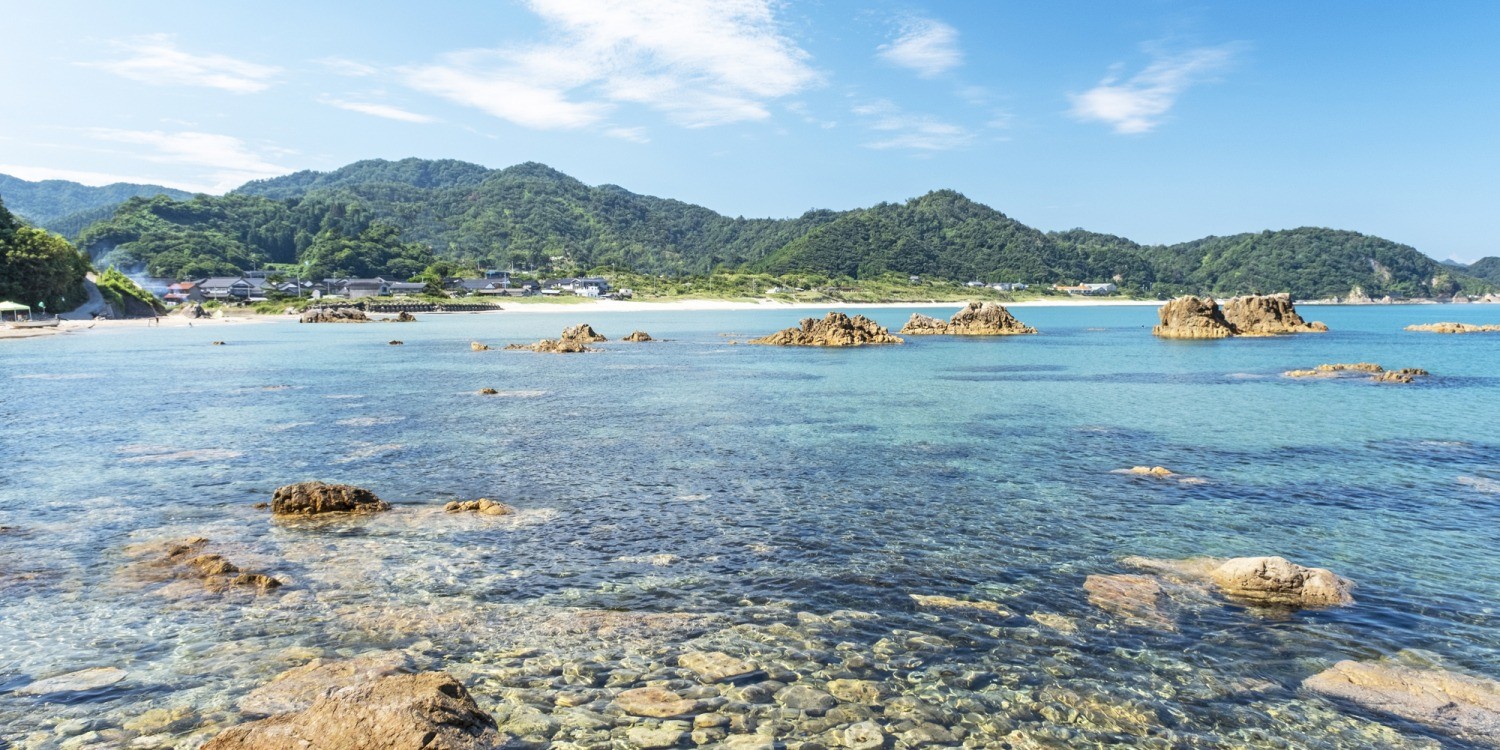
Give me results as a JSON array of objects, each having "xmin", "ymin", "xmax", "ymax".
[{"xmin": 0, "ymin": 0, "xmax": 1500, "ymax": 261}]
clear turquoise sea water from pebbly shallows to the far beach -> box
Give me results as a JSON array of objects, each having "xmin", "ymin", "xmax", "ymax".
[{"xmin": 0, "ymin": 306, "xmax": 1500, "ymax": 747}]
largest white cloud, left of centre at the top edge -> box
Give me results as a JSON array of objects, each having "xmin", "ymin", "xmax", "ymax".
[{"xmin": 407, "ymin": 0, "xmax": 818, "ymax": 129}]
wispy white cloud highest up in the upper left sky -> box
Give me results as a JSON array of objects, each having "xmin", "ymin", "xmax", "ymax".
[{"xmin": 83, "ymin": 35, "xmax": 281, "ymax": 93}]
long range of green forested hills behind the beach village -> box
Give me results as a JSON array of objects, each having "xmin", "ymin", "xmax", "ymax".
[{"xmin": 8, "ymin": 159, "xmax": 1500, "ymax": 299}]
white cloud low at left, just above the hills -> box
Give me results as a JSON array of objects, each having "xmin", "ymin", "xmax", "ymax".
[{"xmin": 86, "ymin": 128, "xmax": 291, "ymax": 192}]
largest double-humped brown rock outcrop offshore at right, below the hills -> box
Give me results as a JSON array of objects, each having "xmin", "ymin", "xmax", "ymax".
[{"xmin": 1151, "ymin": 294, "xmax": 1328, "ymax": 339}]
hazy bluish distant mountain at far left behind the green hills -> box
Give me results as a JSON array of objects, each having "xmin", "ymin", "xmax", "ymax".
[{"xmin": 0, "ymin": 174, "xmax": 192, "ymax": 237}]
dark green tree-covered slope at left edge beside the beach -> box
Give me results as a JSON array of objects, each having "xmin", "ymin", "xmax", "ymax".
[{"xmin": 0, "ymin": 200, "xmax": 89, "ymax": 312}]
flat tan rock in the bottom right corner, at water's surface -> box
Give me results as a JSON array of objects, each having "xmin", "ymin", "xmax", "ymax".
[{"xmin": 1302, "ymin": 660, "xmax": 1500, "ymax": 747}]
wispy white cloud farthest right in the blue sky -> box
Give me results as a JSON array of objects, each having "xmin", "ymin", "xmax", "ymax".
[{"xmin": 1068, "ymin": 44, "xmax": 1242, "ymax": 134}]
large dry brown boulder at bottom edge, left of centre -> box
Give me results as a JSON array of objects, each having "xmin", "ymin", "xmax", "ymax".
[{"xmin": 204, "ymin": 672, "xmax": 504, "ymax": 750}]
